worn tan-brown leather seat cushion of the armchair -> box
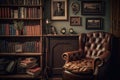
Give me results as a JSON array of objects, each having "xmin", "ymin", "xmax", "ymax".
[{"xmin": 63, "ymin": 59, "xmax": 94, "ymax": 74}]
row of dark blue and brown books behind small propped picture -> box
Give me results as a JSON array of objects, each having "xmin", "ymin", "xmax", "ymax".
[{"xmin": 0, "ymin": 40, "xmax": 40, "ymax": 53}]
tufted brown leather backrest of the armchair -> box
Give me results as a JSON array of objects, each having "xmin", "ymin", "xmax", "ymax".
[{"xmin": 84, "ymin": 32, "xmax": 111, "ymax": 58}]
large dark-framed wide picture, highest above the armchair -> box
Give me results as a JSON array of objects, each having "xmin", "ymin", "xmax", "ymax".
[{"xmin": 81, "ymin": 1, "xmax": 105, "ymax": 15}]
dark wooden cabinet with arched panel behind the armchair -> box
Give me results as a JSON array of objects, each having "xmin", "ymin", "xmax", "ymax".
[{"xmin": 46, "ymin": 35, "xmax": 79, "ymax": 77}]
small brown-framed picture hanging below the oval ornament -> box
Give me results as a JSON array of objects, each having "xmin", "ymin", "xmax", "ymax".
[{"xmin": 70, "ymin": 16, "xmax": 82, "ymax": 26}]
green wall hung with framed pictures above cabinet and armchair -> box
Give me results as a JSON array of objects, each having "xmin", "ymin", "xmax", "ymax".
[{"xmin": 45, "ymin": 0, "xmax": 110, "ymax": 34}]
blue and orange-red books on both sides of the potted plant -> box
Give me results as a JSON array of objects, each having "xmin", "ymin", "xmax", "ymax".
[{"xmin": 0, "ymin": 23, "xmax": 41, "ymax": 35}]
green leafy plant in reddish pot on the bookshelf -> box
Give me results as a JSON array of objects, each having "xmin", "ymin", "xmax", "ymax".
[{"xmin": 14, "ymin": 21, "xmax": 24, "ymax": 35}]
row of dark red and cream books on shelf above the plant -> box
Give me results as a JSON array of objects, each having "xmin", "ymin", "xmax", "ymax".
[{"xmin": 0, "ymin": 7, "xmax": 40, "ymax": 19}]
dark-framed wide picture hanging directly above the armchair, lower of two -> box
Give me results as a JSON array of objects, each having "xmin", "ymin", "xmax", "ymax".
[{"xmin": 86, "ymin": 18, "xmax": 104, "ymax": 30}]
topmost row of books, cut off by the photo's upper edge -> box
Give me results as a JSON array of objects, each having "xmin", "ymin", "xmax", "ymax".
[{"xmin": 0, "ymin": 0, "xmax": 42, "ymax": 5}]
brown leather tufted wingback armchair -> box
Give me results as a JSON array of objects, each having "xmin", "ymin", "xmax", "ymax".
[{"xmin": 62, "ymin": 31, "xmax": 112, "ymax": 80}]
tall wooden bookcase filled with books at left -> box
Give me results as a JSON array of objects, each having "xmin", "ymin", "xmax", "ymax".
[{"xmin": 0, "ymin": 0, "xmax": 44, "ymax": 80}]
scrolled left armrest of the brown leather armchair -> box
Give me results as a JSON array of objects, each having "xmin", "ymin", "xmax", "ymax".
[{"xmin": 62, "ymin": 50, "xmax": 83, "ymax": 62}]
